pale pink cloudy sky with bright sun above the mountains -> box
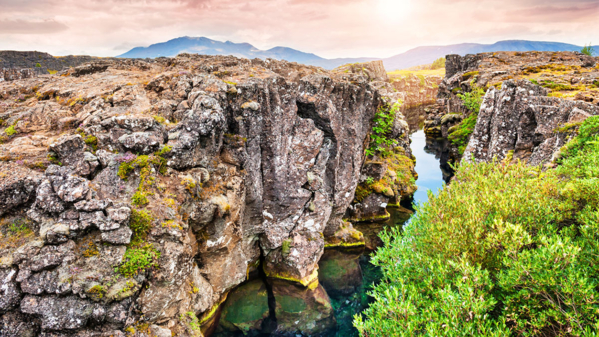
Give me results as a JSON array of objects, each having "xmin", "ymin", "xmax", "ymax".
[{"xmin": 0, "ymin": 0, "xmax": 599, "ymax": 58}]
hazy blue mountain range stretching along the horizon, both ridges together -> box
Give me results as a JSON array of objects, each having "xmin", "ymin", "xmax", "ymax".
[{"xmin": 117, "ymin": 36, "xmax": 599, "ymax": 70}]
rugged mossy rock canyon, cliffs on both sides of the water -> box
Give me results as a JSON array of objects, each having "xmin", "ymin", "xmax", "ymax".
[{"xmin": 0, "ymin": 48, "xmax": 599, "ymax": 337}]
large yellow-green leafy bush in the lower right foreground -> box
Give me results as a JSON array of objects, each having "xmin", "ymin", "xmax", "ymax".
[{"xmin": 354, "ymin": 117, "xmax": 599, "ymax": 336}]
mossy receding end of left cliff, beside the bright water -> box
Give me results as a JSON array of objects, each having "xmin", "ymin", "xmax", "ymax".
[{"xmin": 333, "ymin": 61, "xmax": 420, "ymax": 223}]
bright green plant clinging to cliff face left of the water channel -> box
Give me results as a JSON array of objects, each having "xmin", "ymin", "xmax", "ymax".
[{"xmin": 366, "ymin": 101, "xmax": 403, "ymax": 157}]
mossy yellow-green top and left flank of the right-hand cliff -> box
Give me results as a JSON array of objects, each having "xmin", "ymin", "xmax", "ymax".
[{"xmin": 425, "ymin": 52, "xmax": 599, "ymax": 161}]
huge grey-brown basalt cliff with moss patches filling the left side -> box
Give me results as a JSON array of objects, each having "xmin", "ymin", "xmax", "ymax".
[{"xmin": 0, "ymin": 55, "xmax": 381, "ymax": 336}]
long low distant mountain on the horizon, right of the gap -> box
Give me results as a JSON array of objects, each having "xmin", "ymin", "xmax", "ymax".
[{"xmin": 383, "ymin": 40, "xmax": 599, "ymax": 71}]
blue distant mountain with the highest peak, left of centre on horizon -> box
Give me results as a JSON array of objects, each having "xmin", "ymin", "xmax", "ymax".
[{"xmin": 117, "ymin": 36, "xmax": 375, "ymax": 69}]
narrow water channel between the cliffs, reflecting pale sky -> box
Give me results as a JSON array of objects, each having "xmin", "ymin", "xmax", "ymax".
[{"xmin": 215, "ymin": 107, "xmax": 453, "ymax": 337}]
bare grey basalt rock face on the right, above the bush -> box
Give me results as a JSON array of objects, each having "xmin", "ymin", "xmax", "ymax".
[{"xmin": 464, "ymin": 80, "xmax": 599, "ymax": 165}]
